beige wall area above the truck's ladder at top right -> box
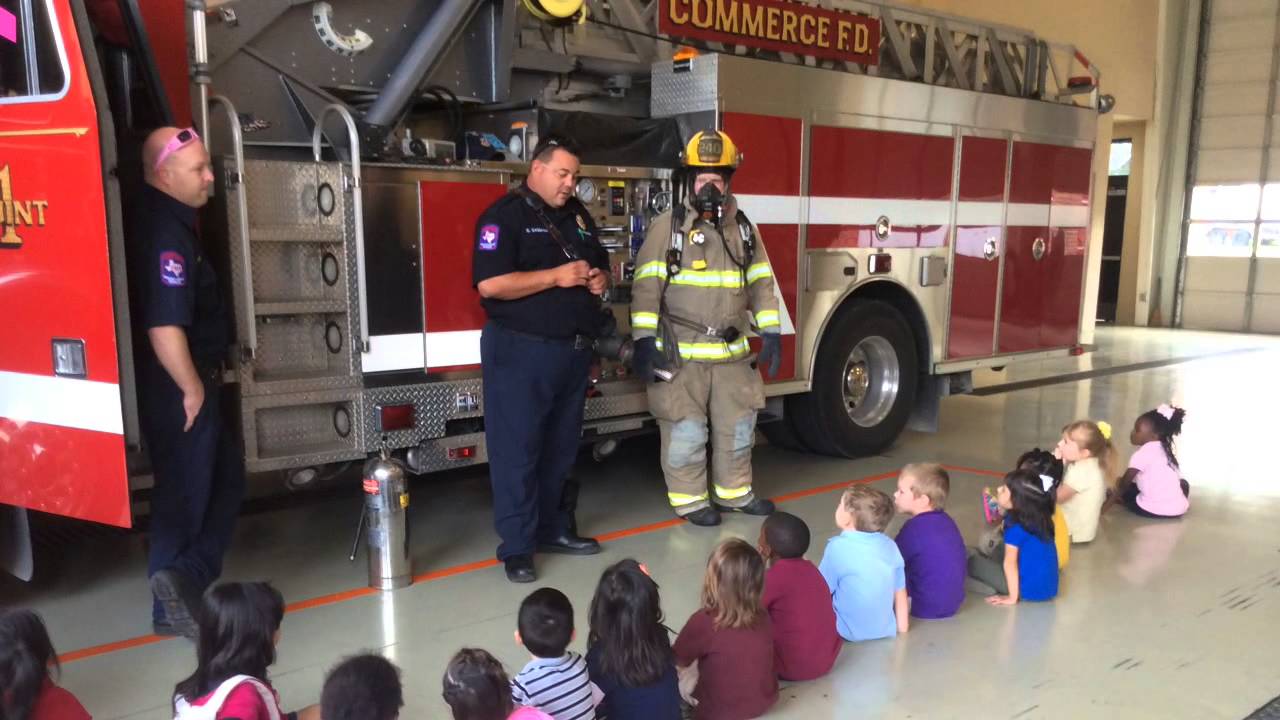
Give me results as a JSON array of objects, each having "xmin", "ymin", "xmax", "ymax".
[{"xmin": 902, "ymin": 0, "xmax": 1160, "ymax": 119}]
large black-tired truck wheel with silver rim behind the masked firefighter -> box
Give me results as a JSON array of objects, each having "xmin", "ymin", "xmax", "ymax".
[{"xmin": 787, "ymin": 301, "xmax": 919, "ymax": 457}]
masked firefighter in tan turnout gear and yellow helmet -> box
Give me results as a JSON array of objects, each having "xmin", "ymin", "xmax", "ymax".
[{"xmin": 631, "ymin": 131, "xmax": 781, "ymax": 525}]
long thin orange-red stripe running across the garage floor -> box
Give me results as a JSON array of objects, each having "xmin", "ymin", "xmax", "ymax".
[{"xmin": 58, "ymin": 465, "xmax": 1005, "ymax": 664}]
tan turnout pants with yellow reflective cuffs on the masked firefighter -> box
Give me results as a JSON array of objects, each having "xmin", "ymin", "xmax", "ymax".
[{"xmin": 649, "ymin": 357, "xmax": 764, "ymax": 516}]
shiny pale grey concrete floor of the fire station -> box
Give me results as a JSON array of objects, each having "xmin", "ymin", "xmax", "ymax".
[{"xmin": 0, "ymin": 329, "xmax": 1280, "ymax": 720}]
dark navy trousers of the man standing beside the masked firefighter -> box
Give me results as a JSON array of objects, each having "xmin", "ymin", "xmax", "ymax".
[{"xmin": 480, "ymin": 323, "xmax": 591, "ymax": 560}]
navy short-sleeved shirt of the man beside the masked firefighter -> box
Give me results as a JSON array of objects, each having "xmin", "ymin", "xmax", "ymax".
[{"xmin": 471, "ymin": 188, "xmax": 609, "ymax": 338}]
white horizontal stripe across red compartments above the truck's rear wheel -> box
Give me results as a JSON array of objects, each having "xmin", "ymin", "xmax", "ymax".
[{"xmin": 736, "ymin": 195, "xmax": 1089, "ymax": 228}]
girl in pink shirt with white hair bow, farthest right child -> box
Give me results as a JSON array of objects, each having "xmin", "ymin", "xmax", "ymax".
[{"xmin": 1116, "ymin": 405, "xmax": 1190, "ymax": 518}]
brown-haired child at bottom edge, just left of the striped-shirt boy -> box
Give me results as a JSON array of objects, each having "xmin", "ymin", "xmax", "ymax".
[{"xmin": 440, "ymin": 647, "xmax": 552, "ymax": 720}]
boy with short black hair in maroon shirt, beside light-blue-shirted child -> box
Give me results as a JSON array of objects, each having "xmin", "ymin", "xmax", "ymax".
[{"xmin": 756, "ymin": 511, "xmax": 844, "ymax": 680}]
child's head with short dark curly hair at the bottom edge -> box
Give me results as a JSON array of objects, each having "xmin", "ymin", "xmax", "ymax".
[{"xmin": 320, "ymin": 653, "xmax": 404, "ymax": 720}]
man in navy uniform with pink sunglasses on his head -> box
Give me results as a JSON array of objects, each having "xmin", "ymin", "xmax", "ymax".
[{"xmin": 128, "ymin": 128, "xmax": 244, "ymax": 638}]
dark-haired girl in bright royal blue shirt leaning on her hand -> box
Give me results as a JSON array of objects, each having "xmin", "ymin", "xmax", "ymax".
[{"xmin": 969, "ymin": 469, "xmax": 1057, "ymax": 605}]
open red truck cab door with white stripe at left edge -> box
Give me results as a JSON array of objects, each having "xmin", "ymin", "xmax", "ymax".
[{"xmin": 0, "ymin": 0, "xmax": 131, "ymax": 527}]
